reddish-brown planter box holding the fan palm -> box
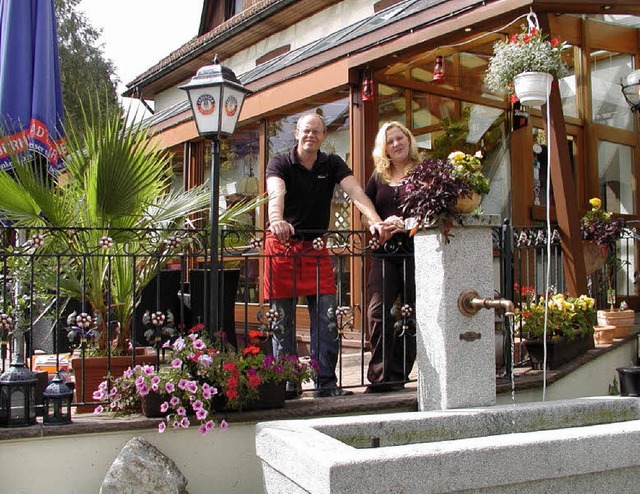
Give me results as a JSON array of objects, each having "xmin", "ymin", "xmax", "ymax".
[{"xmin": 71, "ymin": 354, "xmax": 156, "ymax": 413}]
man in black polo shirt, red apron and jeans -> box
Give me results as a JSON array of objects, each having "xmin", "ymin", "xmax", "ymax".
[{"xmin": 264, "ymin": 113, "xmax": 387, "ymax": 398}]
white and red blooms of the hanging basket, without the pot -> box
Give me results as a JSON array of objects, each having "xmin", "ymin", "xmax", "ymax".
[{"xmin": 484, "ymin": 25, "xmax": 569, "ymax": 97}]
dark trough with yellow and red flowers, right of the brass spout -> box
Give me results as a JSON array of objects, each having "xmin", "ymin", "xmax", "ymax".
[{"xmin": 517, "ymin": 293, "xmax": 596, "ymax": 369}]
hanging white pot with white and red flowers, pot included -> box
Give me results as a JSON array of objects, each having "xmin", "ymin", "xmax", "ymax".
[{"xmin": 485, "ymin": 21, "xmax": 569, "ymax": 106}]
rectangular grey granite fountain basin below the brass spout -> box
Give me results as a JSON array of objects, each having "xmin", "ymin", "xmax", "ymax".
[{"xmin": 256, "ymin": 397, "xmax": 640, "ymax": 494}]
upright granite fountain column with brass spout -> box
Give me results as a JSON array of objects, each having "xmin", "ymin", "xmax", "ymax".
[{"xmin": 415, "ymin": 215, "xmax": 500, "ymax": 411}]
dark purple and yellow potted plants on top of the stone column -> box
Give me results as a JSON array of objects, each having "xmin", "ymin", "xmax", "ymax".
[{"xmin": 401, "ymin": 151, "xmax": 489, "ymax": 239}]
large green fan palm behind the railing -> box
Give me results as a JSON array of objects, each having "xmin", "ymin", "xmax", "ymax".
[{"xmin": 0, "ymin": 105, "xmax": 262, "ymax": 353}]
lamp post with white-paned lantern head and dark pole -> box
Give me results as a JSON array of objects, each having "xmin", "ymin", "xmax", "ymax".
[{"xmin": 180, "ymin": 55, "xmax": 250, "ymax": 337}]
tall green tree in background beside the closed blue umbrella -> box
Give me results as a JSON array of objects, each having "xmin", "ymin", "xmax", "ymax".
[{"xmin": 54, "ymin": 0, "xmax": 118, "ymax": 125}]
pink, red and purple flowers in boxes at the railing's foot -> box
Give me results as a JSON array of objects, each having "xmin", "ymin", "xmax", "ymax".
[{"xmin": 93, "ymin": 325, "xmax": 316, "ymax": 435}]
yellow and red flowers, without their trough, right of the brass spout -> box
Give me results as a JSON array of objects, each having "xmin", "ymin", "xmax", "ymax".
[{"xmin": 517, "ymin": 293, "xmax": 596, "ymax": 341}]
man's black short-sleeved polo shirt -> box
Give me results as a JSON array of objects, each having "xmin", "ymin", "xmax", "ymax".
[{"xmin": 267, "ymin": 150, "xmax": 353, "ymax": 238}]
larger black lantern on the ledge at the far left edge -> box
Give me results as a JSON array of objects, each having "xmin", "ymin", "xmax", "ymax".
[{"xmin": 0, "ymin": 352, "xmax": 37, "ymax": 427}]
